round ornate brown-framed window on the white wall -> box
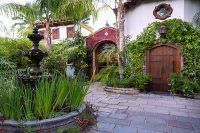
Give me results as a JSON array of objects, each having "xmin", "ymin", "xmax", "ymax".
[{"xmin": 153, "ymin": 3, "xmax": 173, "ymax": 20}]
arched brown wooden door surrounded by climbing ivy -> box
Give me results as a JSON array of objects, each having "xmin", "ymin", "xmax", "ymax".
[{"xmin": 147, "ymin": 44, "xmax": 181, "ymax": 92}]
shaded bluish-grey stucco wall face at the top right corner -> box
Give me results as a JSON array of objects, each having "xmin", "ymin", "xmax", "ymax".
[{"xmin": 184, "ymin": 0, "xmax": 200, "ymax": 22}]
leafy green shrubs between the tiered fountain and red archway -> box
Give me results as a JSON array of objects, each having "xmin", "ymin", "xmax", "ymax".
[{"xmin": 42, "ymin": 32, "xmax": 90, "ymax": 74}]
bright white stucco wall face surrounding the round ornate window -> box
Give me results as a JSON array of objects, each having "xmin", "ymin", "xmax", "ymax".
[{"xmin": 125, "ymin": 0, "xmax": 185, "ymax": 39}]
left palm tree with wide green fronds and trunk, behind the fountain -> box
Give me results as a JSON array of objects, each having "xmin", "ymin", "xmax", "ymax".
[{"xmin": 0, "ymin": 0, "xmax": 98, "ymax": 48}]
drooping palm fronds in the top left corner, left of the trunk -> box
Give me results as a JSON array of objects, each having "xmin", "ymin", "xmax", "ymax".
[{"xmin": 0, "ymin": 2, "xmax": 41, "ymax": 36}]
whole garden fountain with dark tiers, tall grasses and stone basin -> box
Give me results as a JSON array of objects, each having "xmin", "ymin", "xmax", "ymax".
[{"xmin": 0, "ymin": 27, "xmax": 86, "ymax": 133}]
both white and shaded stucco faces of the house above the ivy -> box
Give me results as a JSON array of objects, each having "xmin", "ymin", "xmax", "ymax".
[{"xmin": 124, "ymin": 0, "xmax": 200, "ymax": 39}]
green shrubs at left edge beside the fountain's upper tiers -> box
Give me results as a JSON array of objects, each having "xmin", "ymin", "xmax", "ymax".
[{"xmin": 0, "ymin": 38, "xmax": 31, "ymax": 68}]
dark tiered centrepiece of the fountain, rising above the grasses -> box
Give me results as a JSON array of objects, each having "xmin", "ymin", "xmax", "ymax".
[{"xmin": 18, "ymin": 27, "xmax": 47, "ymax": 86}]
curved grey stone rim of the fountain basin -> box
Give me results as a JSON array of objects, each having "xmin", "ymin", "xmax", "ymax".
[{"xmin": 3, "ymin": 103, "xmax": 86, "ymax": 133}]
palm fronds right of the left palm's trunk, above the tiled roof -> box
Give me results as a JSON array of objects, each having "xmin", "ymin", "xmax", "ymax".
[{"xmin": 59, "ymin": 0, "xmax": 99, "ymax": 32}]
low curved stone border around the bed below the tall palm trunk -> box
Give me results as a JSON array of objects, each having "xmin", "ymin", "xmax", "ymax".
[{"xmin": 104, "ymin": 86, "xmax": 139, "ymax": 95}]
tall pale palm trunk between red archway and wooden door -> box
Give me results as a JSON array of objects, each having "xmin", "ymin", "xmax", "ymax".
[{"xmin": 117, "ymin": 0, "xmax": 124, "ymax": 80}]
